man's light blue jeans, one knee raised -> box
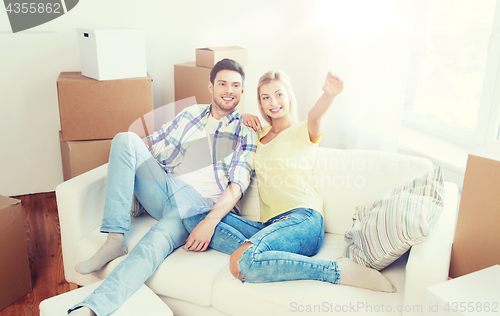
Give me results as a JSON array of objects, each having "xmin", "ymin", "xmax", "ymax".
[{"xmin": 70, "ymin": 133, "xmax": 213, "ymax": 316}]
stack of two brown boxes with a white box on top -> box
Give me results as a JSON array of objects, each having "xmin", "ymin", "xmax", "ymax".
[{"xmin": 57, "ymin": 29, "xmax": 153, "ymax": 181}]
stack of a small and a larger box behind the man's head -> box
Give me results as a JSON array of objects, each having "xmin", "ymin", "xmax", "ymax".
[{"xmin": 174, "ymin": 46, "xmax": 248, "ymax": 114}]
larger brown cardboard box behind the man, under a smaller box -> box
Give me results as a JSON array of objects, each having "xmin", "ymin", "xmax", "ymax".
[{"xmin": 174, "ymin": 61, "xmax": 245, "ymax": 114}]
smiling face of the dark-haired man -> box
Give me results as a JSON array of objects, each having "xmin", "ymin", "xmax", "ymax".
[{"xmin": 208, "ymin": 70, "xmax": 243, "ymax": 119}]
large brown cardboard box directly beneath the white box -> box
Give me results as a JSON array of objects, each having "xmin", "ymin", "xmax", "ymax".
[{"xmin": 57, "ymin": 72, "xmax": 153, "ymax": 141}]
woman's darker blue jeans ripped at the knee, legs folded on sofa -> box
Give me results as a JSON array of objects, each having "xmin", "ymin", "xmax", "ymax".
[{"xmin": 183, "ymin": 207, "xmax": 340, "ymax": 284}]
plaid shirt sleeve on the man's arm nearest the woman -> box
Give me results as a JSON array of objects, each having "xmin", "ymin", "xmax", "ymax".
[{"xmin": 228, "ymin": 124, "xmax": 257, "ymax": 195}]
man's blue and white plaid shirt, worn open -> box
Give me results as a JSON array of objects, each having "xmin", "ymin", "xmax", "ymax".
[{"xmin": 148, "ymin": 104, "xmax": 257, "ymax": 211}]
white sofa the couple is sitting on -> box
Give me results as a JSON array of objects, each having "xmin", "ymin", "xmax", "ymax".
[{"xmin": 56, "ymin": 148, "xmax": 458, "ymax": 316}]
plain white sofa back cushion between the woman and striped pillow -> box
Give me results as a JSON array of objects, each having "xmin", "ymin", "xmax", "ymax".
[{"xmin": 312, "ymin": 148, "xmax": 432, "ymax": 235}]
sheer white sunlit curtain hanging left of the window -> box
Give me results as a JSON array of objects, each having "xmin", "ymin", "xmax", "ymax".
[{"xmin": 319, "ymin": 0, "xmax": 415, "ymax": 152}]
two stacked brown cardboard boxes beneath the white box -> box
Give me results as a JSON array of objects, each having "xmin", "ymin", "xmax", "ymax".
[{"xmin": 57, "ymin": 72, "xmax": 153, "ymax": 181}]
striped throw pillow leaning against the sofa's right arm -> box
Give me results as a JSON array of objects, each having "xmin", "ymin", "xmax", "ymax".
[{"xmin": 344, "ymin": 168, "xmax": 444, "ymax": 270}]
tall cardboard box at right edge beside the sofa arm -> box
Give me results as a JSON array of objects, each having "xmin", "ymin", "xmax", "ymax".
[{"xmin": 450, "ymin": 140, "xmax": 500, "ymax": 278}]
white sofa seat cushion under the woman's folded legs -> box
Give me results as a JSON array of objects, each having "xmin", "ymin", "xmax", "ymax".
[{"xmin": 212, "ymin": 234, "xmax": 405, "ymax": 316}]
